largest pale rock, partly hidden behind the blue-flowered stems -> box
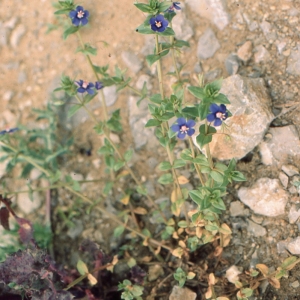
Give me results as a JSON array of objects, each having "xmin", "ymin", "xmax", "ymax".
[{"xmin": 210, "ymin": 75, "xmax": 274, "ymax": 160}]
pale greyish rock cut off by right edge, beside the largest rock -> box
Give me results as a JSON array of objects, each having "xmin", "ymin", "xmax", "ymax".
[{"xmin": 259, "ymin": 125, "xmax": 300, "ymax": 167}]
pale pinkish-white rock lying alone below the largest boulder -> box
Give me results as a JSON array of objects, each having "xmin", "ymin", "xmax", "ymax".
[{"xmin": 238, "ymin": 178, "xmax": 289, "ymax": 217}]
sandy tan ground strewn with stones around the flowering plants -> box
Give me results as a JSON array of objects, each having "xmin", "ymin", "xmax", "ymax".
[{"xmin": 0, "ymin": 0, "xmax": 300, "ymax": 300}]
